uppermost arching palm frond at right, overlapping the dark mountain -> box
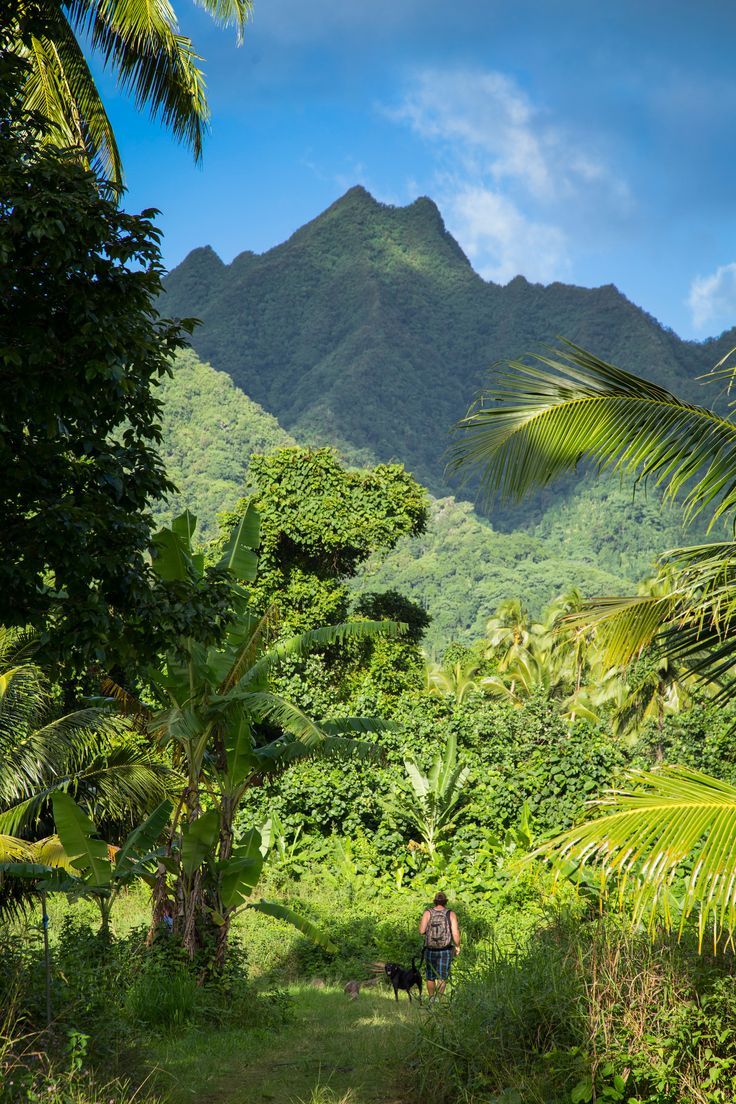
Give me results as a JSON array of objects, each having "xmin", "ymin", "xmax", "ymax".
[{"xmin": 452, "ymin": 342, "xmax": 736, "ymax": 524}]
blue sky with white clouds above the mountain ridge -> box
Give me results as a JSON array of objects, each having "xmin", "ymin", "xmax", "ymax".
[{"xmin": 105, "ymin": 0, "xmax": 736, "ymax": 339}]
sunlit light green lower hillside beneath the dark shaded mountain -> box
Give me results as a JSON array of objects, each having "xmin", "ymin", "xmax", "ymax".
[{"xmin": 159, "ymin": 350, "xmax": 719, "ymax": 652}]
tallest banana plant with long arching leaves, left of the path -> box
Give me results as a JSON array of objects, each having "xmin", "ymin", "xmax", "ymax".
[{"xmin": 129, "ymin": 503, "xmax": 404, "ymax": 965}]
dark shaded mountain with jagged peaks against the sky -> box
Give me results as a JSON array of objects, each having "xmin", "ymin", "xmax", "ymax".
[{"xmin": 162, "ymin": 185, "xmax": 736, "ymax": 493}]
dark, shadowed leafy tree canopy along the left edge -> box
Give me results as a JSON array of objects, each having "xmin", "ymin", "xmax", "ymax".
[{"xmin": 0, "ymin": 52, "xmax": 230, "ymax": 671}]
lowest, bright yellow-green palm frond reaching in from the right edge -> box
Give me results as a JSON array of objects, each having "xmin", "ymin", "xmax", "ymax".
[{"xmin": 534, "ymin": 766, "xmax": 736, "ymax": 946}]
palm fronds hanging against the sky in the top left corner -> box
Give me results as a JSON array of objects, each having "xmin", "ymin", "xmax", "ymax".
[{"xmin": 14, "ymin": 0, "xmax": 252, "ymax": 185}]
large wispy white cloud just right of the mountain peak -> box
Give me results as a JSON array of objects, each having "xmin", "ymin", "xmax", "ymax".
[{"xmin": 386, "ymin": 70, "xmax": 631, "ymax": 282}]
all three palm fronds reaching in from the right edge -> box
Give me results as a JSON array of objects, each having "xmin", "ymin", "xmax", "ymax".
[{"xmin": 456, "ymin": 343, "xmax": 736, "ymax": 942}]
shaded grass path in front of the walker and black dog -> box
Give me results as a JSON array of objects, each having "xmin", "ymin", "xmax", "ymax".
[{"xmin": 154, "ymin": 987, "xmax": 425, "ymax": 1104}]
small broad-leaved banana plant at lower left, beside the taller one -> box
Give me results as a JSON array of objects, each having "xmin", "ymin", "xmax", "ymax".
[{"xmin": 0, "ymin": 790, "xmax": 173, "ymax": 934}]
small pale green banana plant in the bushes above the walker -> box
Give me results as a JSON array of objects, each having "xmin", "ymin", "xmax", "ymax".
[{"xmin": 384, "ymin": 733, "xmax": 470, "ymax": 858}]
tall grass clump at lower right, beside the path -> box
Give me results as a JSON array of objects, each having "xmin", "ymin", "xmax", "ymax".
[{"xmin": 416, "ymin": 917, "xmax": 736, "ymax": 1104}]
